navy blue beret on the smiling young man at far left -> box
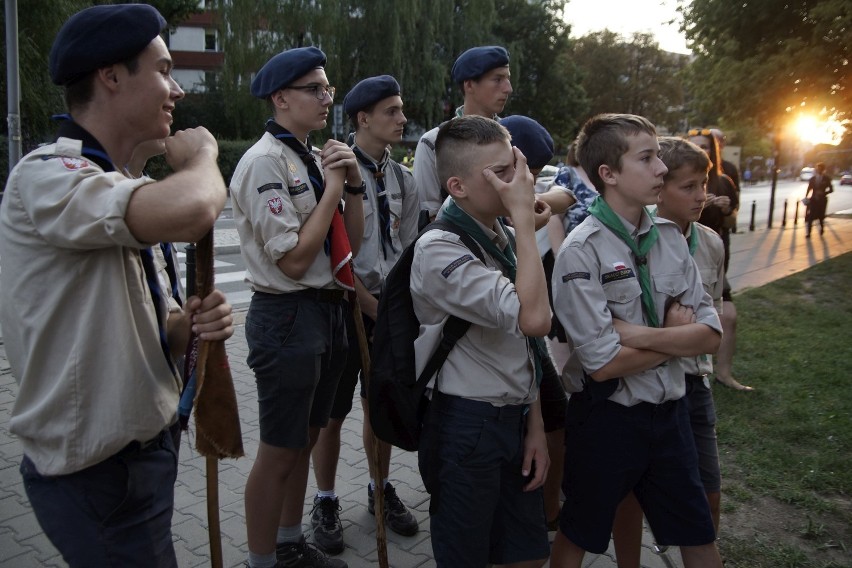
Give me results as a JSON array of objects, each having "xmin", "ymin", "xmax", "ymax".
[{"xmin": 49, "ymin": 4, "xmax": 166, "ymax": 85}]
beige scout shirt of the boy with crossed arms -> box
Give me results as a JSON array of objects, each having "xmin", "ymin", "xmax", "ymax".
[{"xmin": 553, "ymin": 213, "xmax": 722, "ymax": 406}]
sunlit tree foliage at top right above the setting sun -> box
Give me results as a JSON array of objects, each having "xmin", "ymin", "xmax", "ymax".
[{"xmin": 680, "ymin": 0, "xmax": 852, "ymax": 129}]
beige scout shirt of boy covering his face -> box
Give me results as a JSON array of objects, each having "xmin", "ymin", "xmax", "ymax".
[{"xmin": 411, "ymin": 220, "xmax": 538, "ymax": 406}]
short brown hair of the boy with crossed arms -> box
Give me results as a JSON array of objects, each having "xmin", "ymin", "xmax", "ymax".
[{"xmin": 577, "ymin": 113, "xmax": 657, "ymax": 193}]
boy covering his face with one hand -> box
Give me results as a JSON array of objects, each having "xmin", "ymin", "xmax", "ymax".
[{"xmin": 411, "ymin": 116, "xmax": 550, "ymax": 568}]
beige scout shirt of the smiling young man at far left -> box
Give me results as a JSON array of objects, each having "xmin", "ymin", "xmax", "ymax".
[{"xmin": 0, "ymin": 138, "xmax": 179, "ymax": 475}]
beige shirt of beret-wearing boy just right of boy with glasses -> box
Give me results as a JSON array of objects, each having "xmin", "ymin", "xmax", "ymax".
[{"xmin": 354, "ymin": 149, "xmax": 420, "ymax": 294}]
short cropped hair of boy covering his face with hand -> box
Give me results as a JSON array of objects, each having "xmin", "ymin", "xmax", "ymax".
[{"xmin": 435, "ymin": 115, "xmax": 511, "ymax": 187}]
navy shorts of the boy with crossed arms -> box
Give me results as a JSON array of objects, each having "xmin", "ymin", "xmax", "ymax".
[{"xmin": 559, "ymin": 391, "xmax": 716, "ymax": 554}]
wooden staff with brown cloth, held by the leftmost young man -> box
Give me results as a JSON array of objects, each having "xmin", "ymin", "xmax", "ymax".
[{"xmin": 195, "ymin": 229, "xmax": 244, "ymax": 568}]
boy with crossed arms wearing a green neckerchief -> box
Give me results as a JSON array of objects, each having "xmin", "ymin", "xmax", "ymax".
[{"xmin": 551, "ymin": 114, "xmax": 721, "ymax": 568}]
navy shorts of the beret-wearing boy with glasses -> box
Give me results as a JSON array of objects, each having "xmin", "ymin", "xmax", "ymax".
[{"xmin": 246, "ymin": 290, "xmax": 347, "ymax": 449}]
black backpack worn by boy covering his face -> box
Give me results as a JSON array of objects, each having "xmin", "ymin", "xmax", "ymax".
[{"xmin": 367, "ymin": 220, "xmax": 485, "ymax": 451}]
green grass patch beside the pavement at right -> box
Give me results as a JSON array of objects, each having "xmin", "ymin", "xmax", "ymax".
[{"xmin": 714, "ymin": 253, "xmax": 852, "ymax": 567}]
